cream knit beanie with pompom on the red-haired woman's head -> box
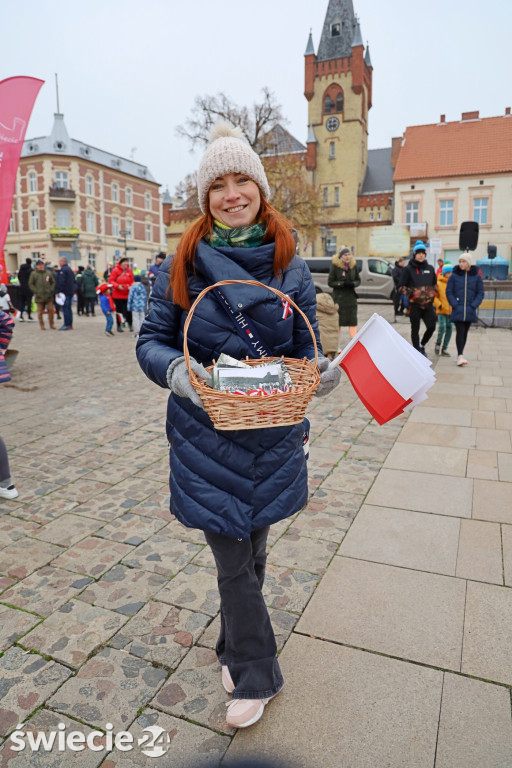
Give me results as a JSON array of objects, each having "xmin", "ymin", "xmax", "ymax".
[{"xmin": 197, "ymin": 120, "xmax": 270, "ymax": 213}]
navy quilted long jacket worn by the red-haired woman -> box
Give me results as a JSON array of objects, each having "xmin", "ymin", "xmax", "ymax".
[{"xmin": 136, "ymin": 241, "xmax": 320, "ymax": 539}]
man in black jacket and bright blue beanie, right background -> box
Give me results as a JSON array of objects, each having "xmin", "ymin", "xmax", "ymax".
[{"xmin": 400, "ymin": 240, "xmax": 437, "ymax": 357}]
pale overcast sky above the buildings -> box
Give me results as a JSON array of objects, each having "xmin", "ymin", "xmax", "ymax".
[{"xmin": 4, "ymin": 0, "xmax": 512, "ymax": 194}]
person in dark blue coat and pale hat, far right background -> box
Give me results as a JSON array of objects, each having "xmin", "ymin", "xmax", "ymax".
[{"xmin": 446, "ymin": 251, "xmax": 484, "ymax": 365}]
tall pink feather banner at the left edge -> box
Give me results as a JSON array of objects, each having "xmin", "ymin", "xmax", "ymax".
[{"xmin": 0, "ymin": 77, "xmax": 44, "ymax": 264}]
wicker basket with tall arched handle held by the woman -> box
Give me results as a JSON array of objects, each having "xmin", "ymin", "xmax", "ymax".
[{"xmin": 183, "ymin": 280, "xmax": 320, "ymax": 429}]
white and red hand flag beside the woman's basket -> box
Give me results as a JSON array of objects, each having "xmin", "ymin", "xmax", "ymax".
[{"xmin": 329, "ymin": 314, "xmax": 435, "ymax": 424}]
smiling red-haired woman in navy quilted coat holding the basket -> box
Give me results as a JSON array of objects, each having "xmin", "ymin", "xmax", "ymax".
[{"xmin": 136, "ymin": 122, "xmax": 341, "ymax": 728}]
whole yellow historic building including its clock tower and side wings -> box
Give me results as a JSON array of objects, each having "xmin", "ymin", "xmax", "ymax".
[{"xmin": 164, "ymin": 0, "xmax": 393, "ymax": 257}]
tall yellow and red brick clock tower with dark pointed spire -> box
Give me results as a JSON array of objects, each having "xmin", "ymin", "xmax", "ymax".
[{"xmin": 304, "ymin": 0, "xmax": 372, "ymax": 256}]
